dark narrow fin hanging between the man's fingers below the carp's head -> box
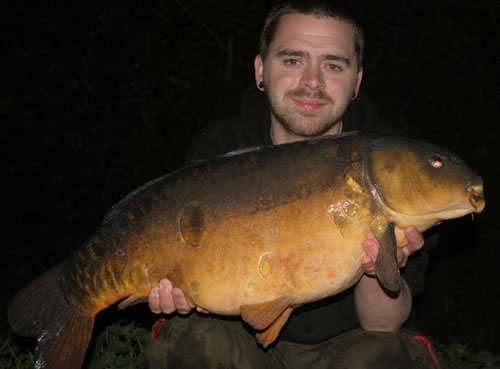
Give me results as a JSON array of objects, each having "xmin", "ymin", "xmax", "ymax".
[{"xmin": 376, "ymin": 223, "xmax": 401, "ymax": 293}]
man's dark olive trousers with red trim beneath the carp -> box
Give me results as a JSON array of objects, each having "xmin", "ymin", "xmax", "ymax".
[{"xmin": 145, "ymin": 314, "xmax": 447, "ymax": 369}]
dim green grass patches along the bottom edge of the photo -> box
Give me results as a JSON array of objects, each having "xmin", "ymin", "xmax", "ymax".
[{"xmin": 0, "ymin": 320, "xmax": 500, "ymax": 369}]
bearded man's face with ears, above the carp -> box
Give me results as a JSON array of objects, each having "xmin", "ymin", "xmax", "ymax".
[{"xmin": 254, "ymin": 14, "xmax": 362, "ymax": 137}]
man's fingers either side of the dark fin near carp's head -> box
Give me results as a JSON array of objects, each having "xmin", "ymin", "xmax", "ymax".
[{"xmin": 361, "ymin": 226, "xmax": 424, "ymax": 276}]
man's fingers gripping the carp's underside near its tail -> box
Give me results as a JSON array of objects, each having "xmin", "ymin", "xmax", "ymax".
[{"xmin": 148, "ymin": 278, "xmax": 208, "ymax": 314}]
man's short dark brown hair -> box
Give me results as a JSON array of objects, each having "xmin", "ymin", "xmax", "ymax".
[{"xmin": 259, "ymin": 0, "xmax": 365, "ymax": 69}]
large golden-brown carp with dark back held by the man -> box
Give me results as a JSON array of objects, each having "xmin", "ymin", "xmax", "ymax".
[{"xmin": 8, "ymin": 134, "xmax": 485, "ymax": 369}]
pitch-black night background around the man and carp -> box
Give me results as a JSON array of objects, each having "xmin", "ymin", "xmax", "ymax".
[{"xmin": 0, "ymin": 0, "xmax": 500, "ymax": 353}]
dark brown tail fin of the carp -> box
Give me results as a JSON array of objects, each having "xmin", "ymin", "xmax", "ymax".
[{"xmin": 8, "ymin": 264, "xmax": 95, "ymax": 369}]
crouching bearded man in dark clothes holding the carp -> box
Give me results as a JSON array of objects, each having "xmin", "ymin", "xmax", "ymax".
[{"xmin": 146, "ymin": 2, "xmax": 445, "ymax": 368}]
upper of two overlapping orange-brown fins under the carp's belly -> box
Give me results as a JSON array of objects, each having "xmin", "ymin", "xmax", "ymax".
[{"xmin": 240, "ymin": 296, "xmax": 291, "ymax": 331}]
